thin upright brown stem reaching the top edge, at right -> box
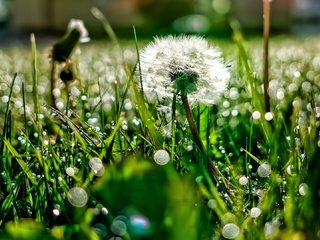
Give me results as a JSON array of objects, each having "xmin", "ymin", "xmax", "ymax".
[{"xmin": 263, "ymin": 0, "xmax": 270, "ymax": 112}]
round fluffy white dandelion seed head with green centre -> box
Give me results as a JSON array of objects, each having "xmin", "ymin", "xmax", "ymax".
[{"xmin": 138, "ymin": 36, "xmax": 230, "ymax": 105}]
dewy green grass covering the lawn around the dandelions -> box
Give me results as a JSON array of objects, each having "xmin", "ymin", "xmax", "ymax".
[{"xmin": 0, "ymin": 31, "xmax": 320, "ymax": 240}]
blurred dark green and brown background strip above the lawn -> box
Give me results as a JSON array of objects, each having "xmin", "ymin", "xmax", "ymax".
[{"xmin": 0, "ymin": 0, "xmax": 320, "ymax": 40}]
